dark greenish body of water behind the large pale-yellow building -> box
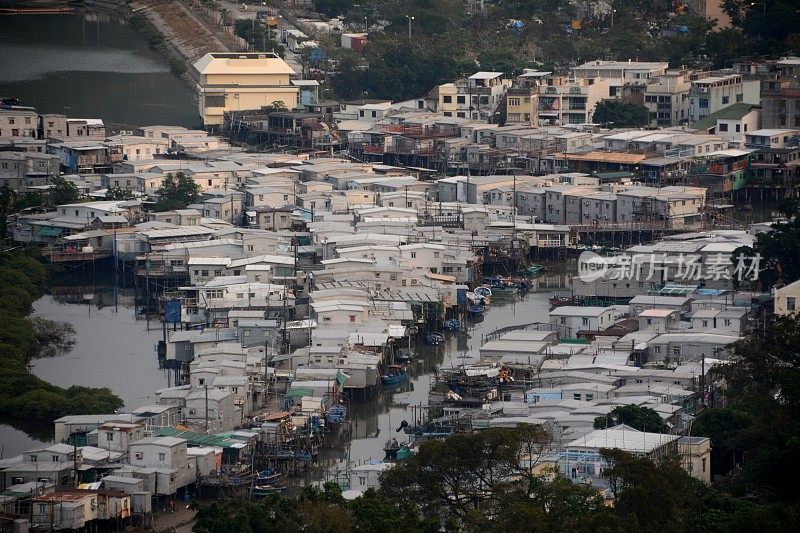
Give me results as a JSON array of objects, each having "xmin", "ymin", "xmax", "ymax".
[{"xmin": 0, "ymin": 9, "xmax": 199, "ymax": 127}]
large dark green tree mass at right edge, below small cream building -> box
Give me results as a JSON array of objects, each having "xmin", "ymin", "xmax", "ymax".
[{"xmin": 692, "ymin": 315, "xmax": 800, "ymax": 503}]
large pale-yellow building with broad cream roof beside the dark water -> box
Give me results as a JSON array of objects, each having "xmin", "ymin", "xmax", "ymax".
[{"xmin": 194, "ymin": 52, "xmax": 298, "ymax": 126}]
